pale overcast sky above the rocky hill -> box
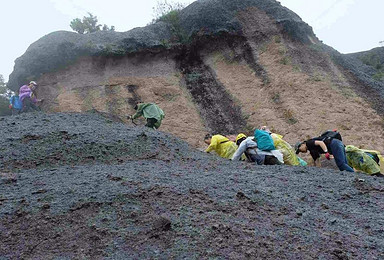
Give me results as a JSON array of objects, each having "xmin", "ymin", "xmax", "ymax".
[{"xmin": 0, "ymin": 0, "xmax": 384, "ymax": 81}]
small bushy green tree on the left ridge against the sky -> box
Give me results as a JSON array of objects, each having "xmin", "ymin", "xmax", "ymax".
[{"xmin": 70, "ymin": 13, "xmax": 115, "ymax": 34}]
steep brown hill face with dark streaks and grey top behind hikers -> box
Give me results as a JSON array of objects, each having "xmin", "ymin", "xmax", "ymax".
[{"xmin": 6, "ymin": 0, "xmax": 384, "ymax": 150}]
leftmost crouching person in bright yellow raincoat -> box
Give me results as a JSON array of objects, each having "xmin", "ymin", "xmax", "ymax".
[{"xmin": 204, "ymin": 134, "xmax": 237, "ymax": 159}]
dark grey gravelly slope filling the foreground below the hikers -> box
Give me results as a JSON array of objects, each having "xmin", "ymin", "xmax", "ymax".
[{"xmin": 0, "ymin": 113, "xmax": 384, "ymax": 259}]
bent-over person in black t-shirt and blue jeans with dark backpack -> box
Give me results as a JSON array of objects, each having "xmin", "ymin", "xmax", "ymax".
[{"xmin": 295, "ymin": 132, "xmax": 354, "ymax": 172}]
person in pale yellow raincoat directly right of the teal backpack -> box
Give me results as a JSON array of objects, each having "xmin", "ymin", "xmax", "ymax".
[{"xmin": 260, "ymin": 126, "xmax": 306, "ymax": 165}]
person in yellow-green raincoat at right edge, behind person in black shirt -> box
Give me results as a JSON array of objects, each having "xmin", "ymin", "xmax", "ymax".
[{"xmin": 345, "ymin": 145, "xmax": 384, "ymax": 177}]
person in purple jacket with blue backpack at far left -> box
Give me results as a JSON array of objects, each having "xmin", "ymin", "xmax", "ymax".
[{"xmin": 9, "ymin": 81, "xmax": 43, "ymax": 115}]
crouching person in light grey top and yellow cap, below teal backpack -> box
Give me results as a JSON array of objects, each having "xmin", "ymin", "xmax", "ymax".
[{"xmin": 232, "ymin": 133, "xmax": 284, "ymax": 165}]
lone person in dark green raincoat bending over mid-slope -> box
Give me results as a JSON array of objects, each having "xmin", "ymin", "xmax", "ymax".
[{"xmin": 128, "ymin": 103, "xmax": 165, "ymax": 129}]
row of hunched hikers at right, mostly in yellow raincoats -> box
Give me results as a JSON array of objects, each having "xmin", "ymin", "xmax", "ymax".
[{"xmin": 204, "ymin": 126, "xmax": 384, "ymax": 177}]
